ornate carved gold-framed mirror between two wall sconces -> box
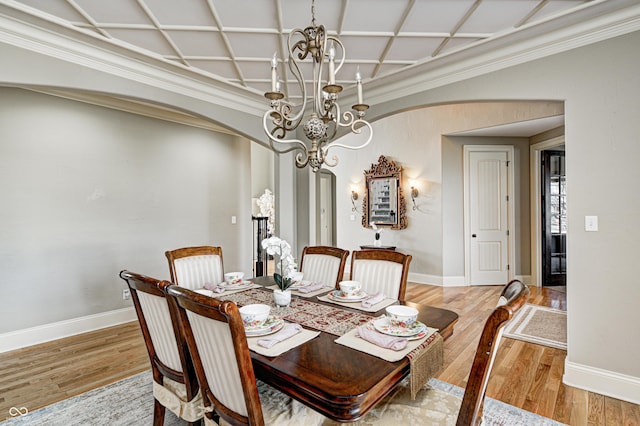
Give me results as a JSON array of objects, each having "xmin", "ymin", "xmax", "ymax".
[{"xmin": 362, "ymin": 155, "xmax": 407, "ymax": 229}]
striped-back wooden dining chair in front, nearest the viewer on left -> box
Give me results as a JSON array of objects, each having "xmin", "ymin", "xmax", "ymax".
[{"xmin": 168, "ymin": 285, "xmax": 325, "ymax": 426}]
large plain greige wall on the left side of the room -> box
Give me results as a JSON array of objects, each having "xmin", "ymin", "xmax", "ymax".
[{"xmin": 0, "ymin": 88, "xmax": 252, "ymax": 333}]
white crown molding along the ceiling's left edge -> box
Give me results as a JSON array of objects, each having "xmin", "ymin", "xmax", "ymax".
[{"xmin": 0, "ymin": 2, "xmax": 265, "ymax": 116}]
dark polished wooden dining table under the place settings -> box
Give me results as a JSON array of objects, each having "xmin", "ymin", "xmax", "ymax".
[{"xmin": 221, "ymin": 276, "xmax": 458, "ymax": 422}]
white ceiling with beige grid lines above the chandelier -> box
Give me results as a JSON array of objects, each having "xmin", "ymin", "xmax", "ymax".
[{"xmin": 3, "ymin": 0, "xmax": 598, "ymax": 101}]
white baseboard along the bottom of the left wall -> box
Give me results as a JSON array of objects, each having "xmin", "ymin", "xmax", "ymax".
[{"xmin": 0, "ymin": 307, "xmax": 137, "ymax": 353}]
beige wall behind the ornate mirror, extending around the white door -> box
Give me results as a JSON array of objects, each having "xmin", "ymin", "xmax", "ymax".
[{"xmin": 331, "ymin": 102, "xmax": 563, "ymax": 284}]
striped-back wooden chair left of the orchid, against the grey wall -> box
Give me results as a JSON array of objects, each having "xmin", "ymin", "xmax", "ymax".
[{"xmin": 165, "ymin": 246, "xmax": 224, "ymax": 289}]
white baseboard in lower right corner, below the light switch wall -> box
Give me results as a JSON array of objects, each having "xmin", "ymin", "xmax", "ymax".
[{"xmin": 562, "ymin": 360, "xmax": 640, "ymax": 404}]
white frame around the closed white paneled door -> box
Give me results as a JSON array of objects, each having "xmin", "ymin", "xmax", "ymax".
[{"xmin": 462, "ymin": 145, "xmax": 516, "ymax": 286}]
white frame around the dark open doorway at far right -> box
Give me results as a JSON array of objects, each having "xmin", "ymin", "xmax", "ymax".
[{"xmin": 529, "ymin": 135, "xmax": 564, "ymax": 287}]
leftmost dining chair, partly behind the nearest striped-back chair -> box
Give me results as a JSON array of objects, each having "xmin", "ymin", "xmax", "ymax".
[{"xmin": 120, "ymin": 270, "xmax": 204, "ymax": 426}]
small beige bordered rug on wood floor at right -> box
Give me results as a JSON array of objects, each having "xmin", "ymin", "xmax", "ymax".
[{"xmin": 503, "ymin": 303, "xmax": 567, "ymax": 350}]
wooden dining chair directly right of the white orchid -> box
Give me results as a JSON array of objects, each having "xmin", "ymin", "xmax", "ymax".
[{"xmin": 300, "ymin": 246, "xmax": 349, "ymax": 288}]
